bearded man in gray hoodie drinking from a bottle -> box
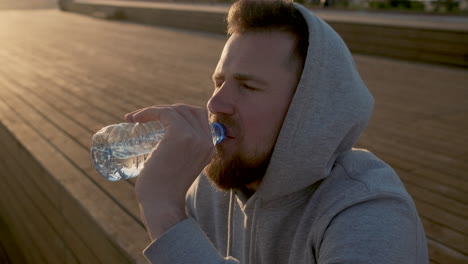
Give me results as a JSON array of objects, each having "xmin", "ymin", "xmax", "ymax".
[{"xmin": 126, "ymin": 0, "xmax": 428, "ymax": 264}]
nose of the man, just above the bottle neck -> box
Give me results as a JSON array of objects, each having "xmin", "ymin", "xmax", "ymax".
[{"xmin": 207, "ymin": 82, "xmax": 235, "ymax": 115}]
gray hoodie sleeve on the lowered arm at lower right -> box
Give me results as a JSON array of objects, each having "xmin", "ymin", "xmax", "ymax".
[{"xmin": 316, "ymin": 195, "xmax": 428, "ymax": 264}]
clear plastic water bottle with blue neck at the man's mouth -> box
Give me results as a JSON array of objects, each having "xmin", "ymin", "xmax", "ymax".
[{"xmin": 91, "ymin": 121, "xmax": 226, "ymax": 181}]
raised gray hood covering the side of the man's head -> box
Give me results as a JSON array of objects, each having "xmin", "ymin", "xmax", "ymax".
[{"xmin": 256, "ymin": 4, "xmax": 373, "ymax": 200}]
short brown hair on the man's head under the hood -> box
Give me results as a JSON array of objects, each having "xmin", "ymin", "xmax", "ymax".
[{"xmin": 227, "ymin": 0, "xmax": 309, "ymax": 69}]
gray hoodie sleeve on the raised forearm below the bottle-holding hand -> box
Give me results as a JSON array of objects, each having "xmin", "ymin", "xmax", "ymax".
[{"xmin": 143, "ymin": 218, "xmax": 239, "ymax": 264}]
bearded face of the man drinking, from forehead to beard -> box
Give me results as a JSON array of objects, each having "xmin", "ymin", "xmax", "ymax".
[{"xmin": 205, "ymin": 31, "xmax": 300, "ymax": 190}]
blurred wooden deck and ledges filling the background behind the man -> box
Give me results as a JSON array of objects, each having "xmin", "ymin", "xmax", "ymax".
[{"xmin": 0, "ymin": 0, "xmax": 468, "ymax": 264}]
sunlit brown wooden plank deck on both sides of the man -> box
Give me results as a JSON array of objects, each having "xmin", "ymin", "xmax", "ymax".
[{"xmin": 0, "ymin": 10, "xmax": 468, "ymax": 264}]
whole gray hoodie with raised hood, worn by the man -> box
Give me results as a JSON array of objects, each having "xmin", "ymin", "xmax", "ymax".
[{"xmin": 144, "ymin": 4, "xmax": 428, "ymax": 264}]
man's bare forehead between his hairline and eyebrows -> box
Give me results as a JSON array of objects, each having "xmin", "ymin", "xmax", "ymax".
[{"xmin": 216, "ymin": 31, "xmax": 295, "ymax": 77}]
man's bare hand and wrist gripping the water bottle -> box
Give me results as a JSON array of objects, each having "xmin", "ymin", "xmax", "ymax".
[{"xmin": 125, "ymin": 105, "xmax": 215, "ymax": 239}]
